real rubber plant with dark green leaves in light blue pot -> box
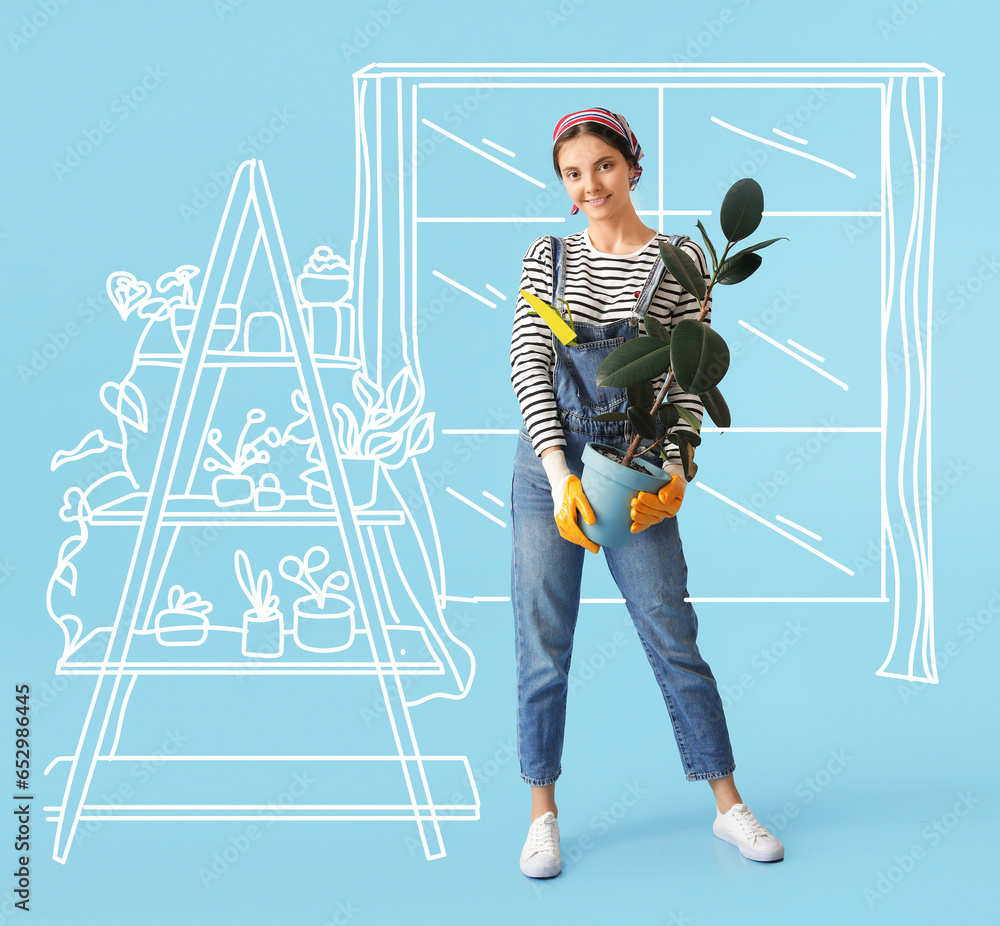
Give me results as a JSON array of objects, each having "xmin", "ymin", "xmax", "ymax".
[{"xmin": 521, "ymin": 177, "xmax": 787, "ymax": 547}]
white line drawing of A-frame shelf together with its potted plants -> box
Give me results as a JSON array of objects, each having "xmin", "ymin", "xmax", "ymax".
[{"xmin": 46, "ymin": 160, "xmax": 479, "ymax": 863}]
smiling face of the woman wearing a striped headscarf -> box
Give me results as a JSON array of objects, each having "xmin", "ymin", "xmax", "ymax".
[{"xmin": 559, "ymin": 135, "xmax": 633, "ymax": 221}]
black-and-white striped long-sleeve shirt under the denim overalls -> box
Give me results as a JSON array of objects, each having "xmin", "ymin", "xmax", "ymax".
[{"xmin": 510, "ymin": 229, "xmax": 711, "ymax": 463}]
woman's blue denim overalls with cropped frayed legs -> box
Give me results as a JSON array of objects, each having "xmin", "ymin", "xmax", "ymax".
[{"xmin": 511, "ymin": 236, "xmax": 736, "ymax": 785}]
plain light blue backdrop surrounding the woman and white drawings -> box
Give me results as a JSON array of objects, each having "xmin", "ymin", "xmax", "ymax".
[{"xmin": 0, "ymin": 0, "xmax": 1000, "ymax": 926}]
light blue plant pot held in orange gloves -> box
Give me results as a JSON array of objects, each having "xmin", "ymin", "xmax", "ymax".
[{"xmin": 577, "ymin": 443, "xmax": 670, "ymax": 548}]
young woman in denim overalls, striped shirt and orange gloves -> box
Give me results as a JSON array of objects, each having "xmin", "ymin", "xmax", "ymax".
[{"xmin": 510, "ymin": 108, "xmax": 784, "ymax": 878}]
